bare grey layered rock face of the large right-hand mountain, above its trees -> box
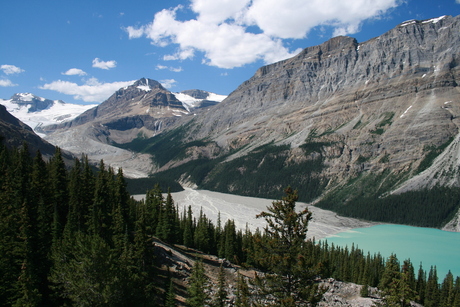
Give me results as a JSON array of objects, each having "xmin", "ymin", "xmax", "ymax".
[{"xmin": 172, "ymin": 16, "xmax": 460, "ymax": 192}]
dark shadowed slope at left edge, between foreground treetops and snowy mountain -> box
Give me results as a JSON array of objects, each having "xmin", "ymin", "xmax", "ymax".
[{"xmin": 0, "ymin": 105, "xmax": 62, "ymax": 158}]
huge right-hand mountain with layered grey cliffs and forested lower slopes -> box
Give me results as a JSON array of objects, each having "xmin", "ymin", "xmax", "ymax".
[{"xmin": 111, "ymin": 16, "xmax": 460, "ymax": 229}]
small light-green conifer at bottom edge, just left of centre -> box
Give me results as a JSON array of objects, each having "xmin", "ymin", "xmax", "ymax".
[{"xmin": 186, "ymin": 260, "xmax": 209, "ymax": 307}]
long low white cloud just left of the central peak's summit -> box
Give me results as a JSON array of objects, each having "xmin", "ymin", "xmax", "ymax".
[{"xmin": 40, "ymin": 78, "xmax": 135, "ymax": 102}]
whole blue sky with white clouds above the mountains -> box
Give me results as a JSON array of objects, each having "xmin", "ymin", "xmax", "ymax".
[{"xmin": 0, "ymin": 0, "xmax": 460, "ymax": 104}]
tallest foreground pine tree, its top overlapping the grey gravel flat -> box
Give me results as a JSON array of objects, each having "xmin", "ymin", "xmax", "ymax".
[{"xmin": 253, "ymin": 187, "xmax": 321, "ymax": 306}]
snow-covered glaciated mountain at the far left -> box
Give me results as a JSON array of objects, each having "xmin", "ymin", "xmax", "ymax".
[{"xmin": 0, "ymin": 93, "xmax": 95, "ymax": 136}]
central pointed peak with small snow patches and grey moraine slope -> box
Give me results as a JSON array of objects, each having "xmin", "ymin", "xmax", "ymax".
[{"xmin": 41, "ymin": 78, "xmax": 225, "ymax": 178}]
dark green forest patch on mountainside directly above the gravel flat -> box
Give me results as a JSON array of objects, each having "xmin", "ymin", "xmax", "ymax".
[{"xmin": 199, "ymin": 143, "xmax": 324, "ymax": 201}]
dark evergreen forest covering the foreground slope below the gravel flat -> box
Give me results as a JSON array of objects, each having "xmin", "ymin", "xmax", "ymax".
[{"xmin": 0, "ymin": 144, "xmax": 460, "ymax": 307}]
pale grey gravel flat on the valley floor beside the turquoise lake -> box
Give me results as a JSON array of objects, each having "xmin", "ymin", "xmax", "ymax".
[{"xmin": 134, "ymin": 188, "xmax": 378, "ymax": 240}]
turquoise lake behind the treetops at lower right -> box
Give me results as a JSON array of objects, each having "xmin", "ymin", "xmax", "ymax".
[{"xmin": 323, "ymin": 225, "xmax": 460, "ymax": 283}]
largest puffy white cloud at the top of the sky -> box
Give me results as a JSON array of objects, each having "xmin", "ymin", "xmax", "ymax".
[{"xmin": 125, "ymin": 0, "xmax": 400, "ymax": 68}]
